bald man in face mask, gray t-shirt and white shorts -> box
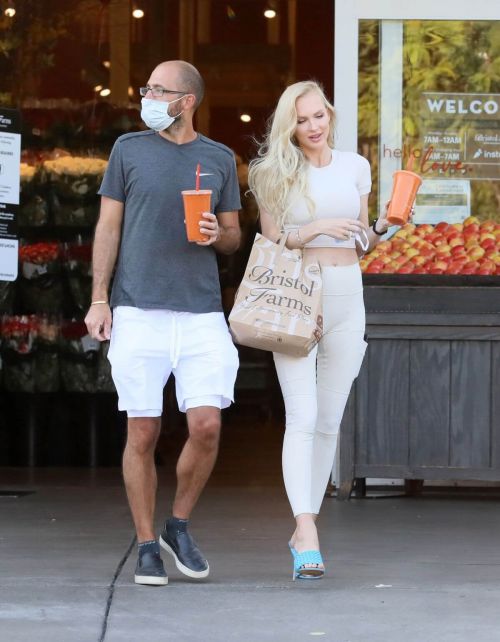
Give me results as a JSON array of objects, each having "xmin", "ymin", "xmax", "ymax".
[{"xmin": 85, "ymin": 60, "xmax": 241, "ymax": 585}]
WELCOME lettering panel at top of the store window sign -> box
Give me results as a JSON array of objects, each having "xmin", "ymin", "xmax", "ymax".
[{"xmin": 421, "ymin": 92, "xmax": 500, "ymax": 120}]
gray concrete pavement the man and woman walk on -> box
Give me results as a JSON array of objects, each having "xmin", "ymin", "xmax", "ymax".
[{"xmin": 0, "ymin": 412, "xmax": 500, "ymax": 642}]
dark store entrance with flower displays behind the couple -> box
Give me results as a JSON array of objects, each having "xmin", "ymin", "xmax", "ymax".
[{"xmin": 0, "ymin": 0, "xmax": 334, "ymax": 466}]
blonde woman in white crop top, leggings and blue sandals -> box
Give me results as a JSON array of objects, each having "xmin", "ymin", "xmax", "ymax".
[{"xmin": 249, "ymin": 81, "xmax": 388, "ymax": 579}]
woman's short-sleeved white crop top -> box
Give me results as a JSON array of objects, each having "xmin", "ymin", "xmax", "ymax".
[{"xmin": 284, "ymin": 149, "xmax": 372, "ymax": 248}]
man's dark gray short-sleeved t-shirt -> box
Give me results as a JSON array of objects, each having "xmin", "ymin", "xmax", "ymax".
[{"xmin": 99, "ymin": 130, "xmax": 241, "ymax": 313}]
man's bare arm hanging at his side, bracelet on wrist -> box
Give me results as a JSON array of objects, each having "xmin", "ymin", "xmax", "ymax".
[{"xmin": 85, "ymin": 196, "xmax": 124, "ymax": 341}]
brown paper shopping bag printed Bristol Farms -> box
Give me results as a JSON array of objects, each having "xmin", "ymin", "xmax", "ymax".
[{"xmin": 229, "ymin": 234, "xmax": 321, "ymax": 357}]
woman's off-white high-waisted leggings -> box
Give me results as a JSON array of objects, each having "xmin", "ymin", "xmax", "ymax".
[{"xmin": 274, "ymin": 263, "xmax": 367, "ymax": 516}]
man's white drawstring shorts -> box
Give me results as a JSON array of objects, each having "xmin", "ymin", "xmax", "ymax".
[{"xmin": 108, "ymin": 306, "xmax": 238, "ymax": 417}]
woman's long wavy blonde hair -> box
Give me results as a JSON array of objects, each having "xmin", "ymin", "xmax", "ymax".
[{"xmin": 248, "ymin": 80, "xmax": 335, "ymax": 227}]
